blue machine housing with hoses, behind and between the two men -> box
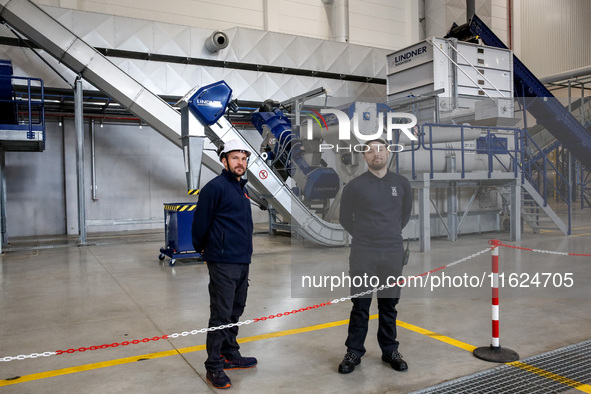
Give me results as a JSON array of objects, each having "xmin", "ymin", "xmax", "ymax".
[{"xmin": 252, "ymin": 108, "xmax": 340, "ymax": 200}]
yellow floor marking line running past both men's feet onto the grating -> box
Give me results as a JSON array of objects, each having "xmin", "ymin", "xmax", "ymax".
[{"xmin": 0, "ymin": 314, "xmax": 591, "ymax": 393}]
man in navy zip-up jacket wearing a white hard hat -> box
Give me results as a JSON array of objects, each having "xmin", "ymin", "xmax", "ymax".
[{"xmin": 192, "ymin": 140, "xmax": 257, "ymax": 388}]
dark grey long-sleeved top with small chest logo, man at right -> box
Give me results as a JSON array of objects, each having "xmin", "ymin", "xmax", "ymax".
[{"xmin": 339, "ymin": 171, "xmax": 412, "ymax": 248}]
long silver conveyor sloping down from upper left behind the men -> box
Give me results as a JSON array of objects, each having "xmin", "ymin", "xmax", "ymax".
[{"xmin": 0, "ymin": 0, "xmax": 347, "ymax": 246}]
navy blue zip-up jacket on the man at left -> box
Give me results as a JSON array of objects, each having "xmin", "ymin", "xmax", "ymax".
[{"xmin": 192, "ymin": 169, "xmax": 253, "ymax": 264}]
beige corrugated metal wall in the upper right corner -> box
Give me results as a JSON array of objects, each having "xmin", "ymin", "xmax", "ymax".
[{"xmin": 515, "ymin": 0, "xmax": 591, "ymax": 78}]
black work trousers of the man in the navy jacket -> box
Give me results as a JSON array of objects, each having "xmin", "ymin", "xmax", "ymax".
[{"xmin": 205, "ymin": 262, "xmax": 250, "ymax": 372}]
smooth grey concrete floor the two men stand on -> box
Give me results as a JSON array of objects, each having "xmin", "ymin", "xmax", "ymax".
[{"xmin": 0, "ymin": 209, "xmax": 591, "ymax": 394}]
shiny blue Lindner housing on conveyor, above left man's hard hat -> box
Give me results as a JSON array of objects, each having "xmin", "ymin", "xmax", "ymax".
[{"xmin": 187, "ymin": 81, "xmax": 232, "ymax": 126}]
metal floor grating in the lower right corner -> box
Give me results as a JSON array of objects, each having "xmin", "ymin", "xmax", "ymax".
[{"xmin": 414, "ymin": 340, "xmax": 591, "ymax": 394}]
